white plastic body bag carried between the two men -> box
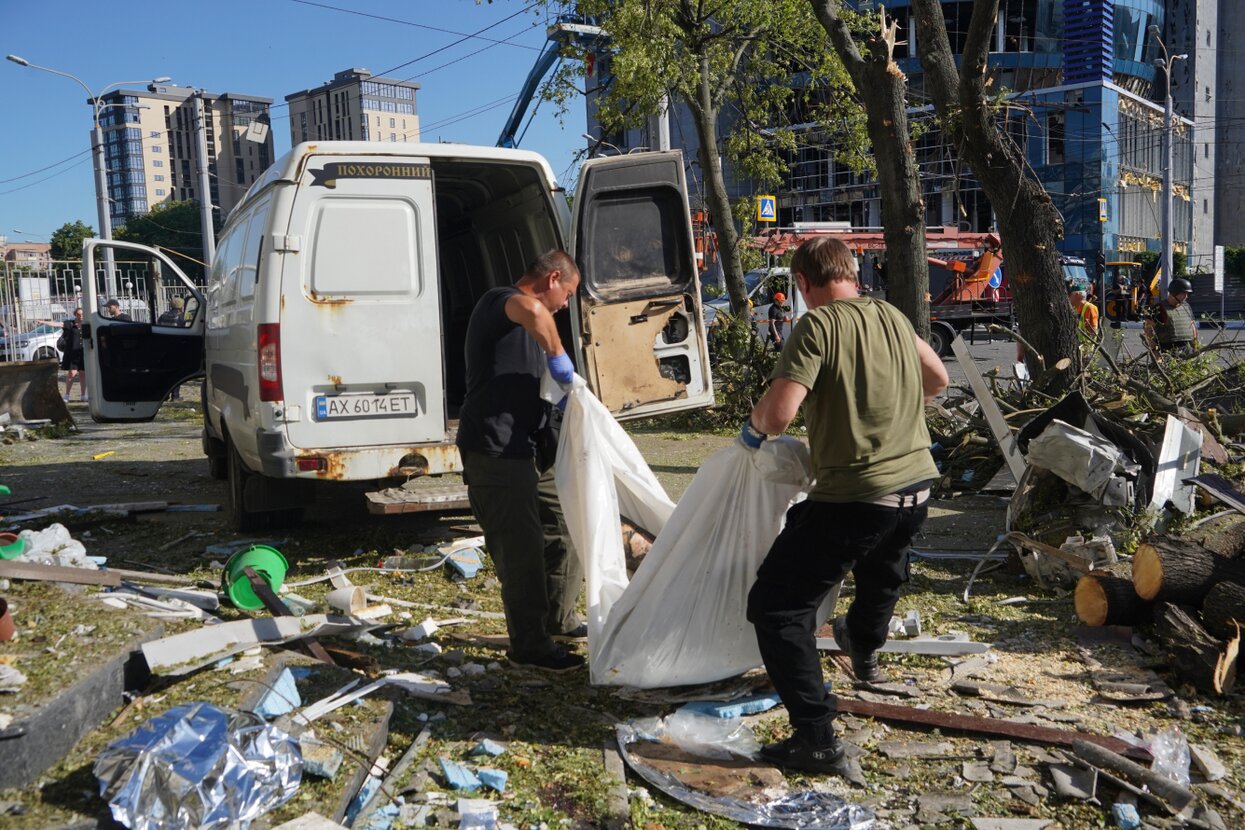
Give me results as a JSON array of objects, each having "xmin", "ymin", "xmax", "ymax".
[{"xmin": 555, "ymin": 378, "xmax": 810, "ymax": 688}]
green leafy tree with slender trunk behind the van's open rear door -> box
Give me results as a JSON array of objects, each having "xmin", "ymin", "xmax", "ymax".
[{"xmin": 545, "ymin": 0, "xmax": 848, "ymax": 315}]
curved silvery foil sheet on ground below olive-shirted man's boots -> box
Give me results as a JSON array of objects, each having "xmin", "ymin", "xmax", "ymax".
[{"xmin": 615, "ymin": 719, "xmax": 875, "ymax": 830}]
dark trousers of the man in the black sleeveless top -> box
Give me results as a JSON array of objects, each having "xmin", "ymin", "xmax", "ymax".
[{"xmin": 462, "ymin": 450, "xmax": 584, "ymax": 660}]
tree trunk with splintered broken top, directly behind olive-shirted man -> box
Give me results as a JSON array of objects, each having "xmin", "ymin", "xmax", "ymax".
[{"xmin": 809, "ymin": 0, "xmax": 930, "ymax": 338}]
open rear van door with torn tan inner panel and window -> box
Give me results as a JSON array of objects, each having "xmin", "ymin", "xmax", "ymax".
[{"xmin": 571, "ymin": 151, "xmax": 713, "ymax": 418}]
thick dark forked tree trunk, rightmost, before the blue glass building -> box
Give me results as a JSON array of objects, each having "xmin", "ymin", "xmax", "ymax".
[{"xmin": 911, "ymin": 0, "xmax": 1079, "ymax": 388}]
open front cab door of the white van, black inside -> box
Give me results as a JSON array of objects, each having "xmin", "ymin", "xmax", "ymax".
[{"xmin": 82, "ymin": 239, "xmax": 205, "ymax": 422}]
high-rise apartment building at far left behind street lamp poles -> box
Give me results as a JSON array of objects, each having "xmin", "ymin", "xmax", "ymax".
[{"xmin": 100, "ymin": 83, "xmax": 273, "ymax": 226}]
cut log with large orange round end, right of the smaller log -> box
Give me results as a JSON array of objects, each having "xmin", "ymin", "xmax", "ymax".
[{"xmin": 1133, "ymin": 536, "xmax": 1245, "ymax": 609}]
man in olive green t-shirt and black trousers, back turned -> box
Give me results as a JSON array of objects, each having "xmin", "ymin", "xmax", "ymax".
[{"xmin": 740, "ymin": 238, "xmax": 947, "ymax": 773}]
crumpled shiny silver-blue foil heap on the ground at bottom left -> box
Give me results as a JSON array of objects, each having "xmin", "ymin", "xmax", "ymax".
[{"xmin": 95, "ymin": 703, "xmax": 303, "ymax": 830}]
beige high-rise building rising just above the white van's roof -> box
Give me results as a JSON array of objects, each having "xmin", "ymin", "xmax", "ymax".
[{"xmin": 285, "ymin": 67, "xmax": 420, "ymax": 144}]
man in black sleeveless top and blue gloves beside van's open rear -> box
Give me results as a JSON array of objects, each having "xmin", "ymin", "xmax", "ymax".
[{"xmin": 457, "ymin": 250, "xmax": 588, "ymax": 672}]
